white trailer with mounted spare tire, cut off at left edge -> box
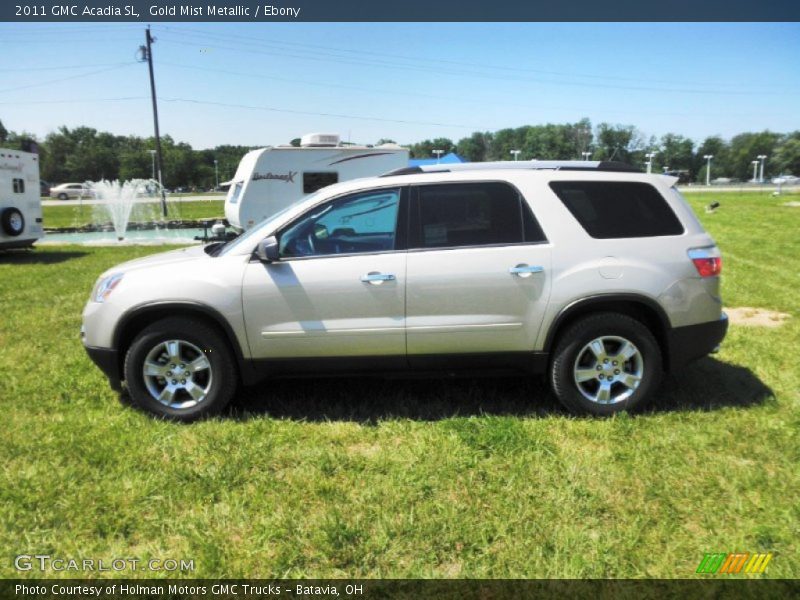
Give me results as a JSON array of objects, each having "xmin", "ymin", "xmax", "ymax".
[{"xmin": 0, "ymin": 148, "xmax": 44, "ymax": 250}]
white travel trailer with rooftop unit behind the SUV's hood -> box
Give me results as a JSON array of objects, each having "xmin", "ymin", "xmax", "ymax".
[{"xmin": 225, "ymin": 133, "xmax": 408, "ymax": 230}]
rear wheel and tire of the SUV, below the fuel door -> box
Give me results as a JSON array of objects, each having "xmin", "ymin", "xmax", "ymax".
[{"xmin": 550, "ymin": 312, "xmax": 663, "ymax": 416}]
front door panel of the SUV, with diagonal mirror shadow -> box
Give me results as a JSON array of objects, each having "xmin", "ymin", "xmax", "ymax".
[{"xmin": 242, "ymin": 252, "xmax": 406, "ymax": 358}]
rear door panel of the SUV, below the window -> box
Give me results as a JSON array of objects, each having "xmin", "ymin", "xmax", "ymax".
[{"xmin": 406, "ymin": 244, "xmax": 551, "ymax": 356}]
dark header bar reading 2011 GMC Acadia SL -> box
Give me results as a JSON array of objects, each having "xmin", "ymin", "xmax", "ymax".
[{"xmin": 0, "ymin": 0, "xmax": 800, "ymax": 23}]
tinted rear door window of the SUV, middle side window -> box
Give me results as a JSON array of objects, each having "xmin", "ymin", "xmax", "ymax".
[{"xmin": 412, "ymin": 182, "xmax": 545, "ymax": 248}]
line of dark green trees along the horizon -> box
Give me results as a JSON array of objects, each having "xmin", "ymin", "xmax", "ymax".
[{"xmin": 0, "ymin": 119, "xmax": 800, "ymax": 188}]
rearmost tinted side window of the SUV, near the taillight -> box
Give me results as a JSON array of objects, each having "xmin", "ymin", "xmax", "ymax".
[{"xmin": 550, "ymin": 181, "xmax": 683, "ymax": 239}]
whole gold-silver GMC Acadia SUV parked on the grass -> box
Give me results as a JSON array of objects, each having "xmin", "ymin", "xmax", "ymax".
[{"xmin": 82, "ymin": 161, "xmax": 727, "ymax": 421}]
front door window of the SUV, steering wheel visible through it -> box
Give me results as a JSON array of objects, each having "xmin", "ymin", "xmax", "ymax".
[{"xmin": 280, "ymin": 189, "xmax": 400, "ymax": 258}]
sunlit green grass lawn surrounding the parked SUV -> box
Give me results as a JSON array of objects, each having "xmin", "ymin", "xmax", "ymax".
[{"xmin": 0, "ymin": 194, "xmax": 800, "ymax": 578}]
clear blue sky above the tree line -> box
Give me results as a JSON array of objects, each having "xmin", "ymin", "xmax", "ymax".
[{"xmin": 0, "ymin": 23, "xmax": 800, "ymax": 148}]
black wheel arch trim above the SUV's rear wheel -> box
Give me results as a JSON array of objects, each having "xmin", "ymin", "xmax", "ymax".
[{"xmin": 544, "ymin": 293, "xmax": 671, "ymax": 370}]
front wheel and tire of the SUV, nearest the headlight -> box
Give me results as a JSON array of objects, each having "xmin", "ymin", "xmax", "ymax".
[{"xmin": 125, "ymin": 317, "xmax": 238, "ymax": 422}]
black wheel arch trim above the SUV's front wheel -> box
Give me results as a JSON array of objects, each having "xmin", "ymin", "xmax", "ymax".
[{"xmin": 113, "ymin": 302, "xmax": 248, "ymax": 380}]
